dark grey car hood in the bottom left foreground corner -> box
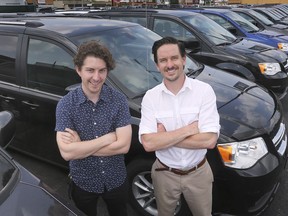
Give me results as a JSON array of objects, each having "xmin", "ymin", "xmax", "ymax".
[{"xmin": 0, "ymin": 163, "xmax": 84, "ymax": 216}]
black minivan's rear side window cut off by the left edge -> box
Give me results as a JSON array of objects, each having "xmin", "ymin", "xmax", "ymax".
[{"xmin": 0, "ymin": 35, "xmax": 18, "ymax": 84}]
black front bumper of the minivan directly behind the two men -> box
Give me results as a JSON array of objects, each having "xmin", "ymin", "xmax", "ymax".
[{"xmin": 213, "ymin": 136, "xmax": 287, "ymax": 215}]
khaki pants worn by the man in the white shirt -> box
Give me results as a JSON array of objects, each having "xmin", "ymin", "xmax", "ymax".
[{"xmin": 151, "ymin": 160, "xmax": 214, "ymax": 216}]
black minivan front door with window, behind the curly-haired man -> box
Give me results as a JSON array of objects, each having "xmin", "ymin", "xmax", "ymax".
[{"xmin": 13, "ymin": 36, "xmax": 81, "ymax": 167}]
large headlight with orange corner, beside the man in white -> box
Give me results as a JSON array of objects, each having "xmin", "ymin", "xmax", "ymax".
[{"xmin": 217, "ymin": 138, "xmax": 268, "ymax": 169}]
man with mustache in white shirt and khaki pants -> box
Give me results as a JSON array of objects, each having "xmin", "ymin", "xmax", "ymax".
[{"xmin": 139, "ymin": 37, "xmax": 220, "ymax": 216}]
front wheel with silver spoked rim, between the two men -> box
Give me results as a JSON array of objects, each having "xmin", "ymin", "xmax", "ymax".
[{"xmin": 127, "ymin": 159, "xmax": 190, "ymax": 216}]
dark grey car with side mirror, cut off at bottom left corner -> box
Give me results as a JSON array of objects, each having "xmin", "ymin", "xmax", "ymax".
[{"xmin": 0, "ymin": 111, "xmax": 84, "ymax": 216}]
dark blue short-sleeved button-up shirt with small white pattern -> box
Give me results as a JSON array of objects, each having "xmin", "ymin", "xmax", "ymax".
[{"xmin": 55, "ymin": 85, "xmax": 131, "ymax": 193}]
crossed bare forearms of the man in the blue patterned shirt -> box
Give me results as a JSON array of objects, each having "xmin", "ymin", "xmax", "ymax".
[{"xmin": 56, "ymin": 125, "xmax": 132, "ymax": 161}]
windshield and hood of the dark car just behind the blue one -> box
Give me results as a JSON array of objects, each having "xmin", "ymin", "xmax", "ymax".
[{"xmin": 232, "ymin": 8, "xmax": 288, "ymax": 35}]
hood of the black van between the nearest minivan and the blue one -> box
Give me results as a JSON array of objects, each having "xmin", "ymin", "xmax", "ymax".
[{"xmin": 225, "ymin": 39, "xmax": 287, "ymax": 63}]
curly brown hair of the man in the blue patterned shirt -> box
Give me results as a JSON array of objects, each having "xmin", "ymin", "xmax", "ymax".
[{"xmin": 73, "ymin": 40, "xmax": 115, "ymax": 71}]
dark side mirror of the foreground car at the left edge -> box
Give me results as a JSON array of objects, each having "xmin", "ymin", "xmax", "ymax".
[{"xmin": 0, "ymin": 111, "xmax": 16, "ymax": 149}]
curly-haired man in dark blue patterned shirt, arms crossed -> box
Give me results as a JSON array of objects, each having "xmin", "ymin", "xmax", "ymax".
[{"xmin": 55, "ymin": 41, "xmax": 132, "ymax": 216}]
